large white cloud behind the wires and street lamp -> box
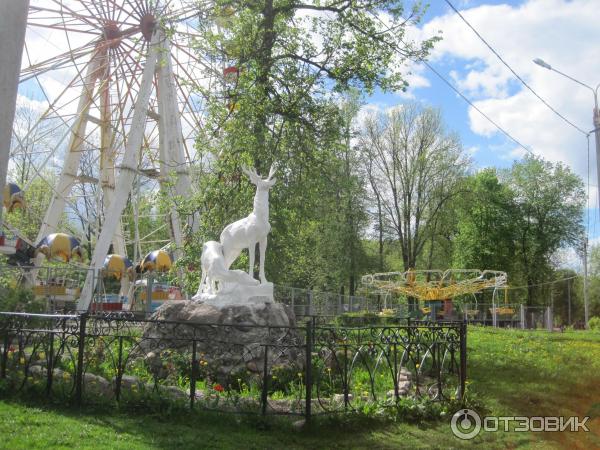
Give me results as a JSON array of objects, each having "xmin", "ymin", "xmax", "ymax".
[{"xmin": 421, "ymin": 0, "xmax": 600, "ymax": 186}]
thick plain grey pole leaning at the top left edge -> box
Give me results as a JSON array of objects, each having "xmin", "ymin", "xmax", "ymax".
[{"xmin": 0, "ymin": 0, "xmax": 29, "ymax": 230}]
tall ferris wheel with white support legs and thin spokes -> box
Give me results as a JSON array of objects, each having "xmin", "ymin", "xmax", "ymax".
[{"xmin": 5, "ymin": 0, "xmax": 223, "ymax": 309}]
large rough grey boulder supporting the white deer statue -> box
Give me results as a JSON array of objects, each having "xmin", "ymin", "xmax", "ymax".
[{"xmin": 140, "ymin": 301, "xmax": 304, "ymax": 385}]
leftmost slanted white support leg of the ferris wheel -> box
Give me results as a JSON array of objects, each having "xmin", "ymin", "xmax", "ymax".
[{"xmin": 36, "ymin": 48, "xmax": 106, "ymax": 243}]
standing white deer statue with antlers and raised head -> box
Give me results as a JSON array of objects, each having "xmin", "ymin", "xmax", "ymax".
[{"xmin": 220, "ymin": 164, "xmax": 277, "ymax": 284}]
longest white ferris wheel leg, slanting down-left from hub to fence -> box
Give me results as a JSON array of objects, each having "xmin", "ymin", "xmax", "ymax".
[{"xmin": 77, "ymin": 33, "xmax": 158, "ymax": 311}]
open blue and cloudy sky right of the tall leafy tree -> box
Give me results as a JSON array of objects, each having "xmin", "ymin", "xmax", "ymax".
[{"xmin": 366, "ymin": 0, "xmax": 600, "ymax": 250}]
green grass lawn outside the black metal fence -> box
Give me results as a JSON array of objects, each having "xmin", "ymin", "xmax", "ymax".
[{"xmin": 0, "ymin": 327, "xmax": 600, "ymax": 450}]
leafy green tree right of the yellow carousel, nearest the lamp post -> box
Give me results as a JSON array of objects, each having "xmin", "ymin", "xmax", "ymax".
[{"xmin": 502, "ymin": 156, "xmax": 585, "ymax": 305}]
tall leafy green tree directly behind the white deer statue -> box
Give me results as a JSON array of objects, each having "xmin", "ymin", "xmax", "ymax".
[{"xmin": 177, "ymin": 0, "xmax": 434, "ymax": 289}]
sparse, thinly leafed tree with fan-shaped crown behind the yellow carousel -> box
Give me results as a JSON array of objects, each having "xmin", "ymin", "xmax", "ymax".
[{"xmin": 360, "ymin": 103, "xmax": 469, "ymax": 270}]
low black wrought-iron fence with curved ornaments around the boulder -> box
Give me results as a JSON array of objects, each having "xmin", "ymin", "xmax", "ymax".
[{"xmin": 0, "ymin": 313, "xmax": 467, "ymax": 419}]
